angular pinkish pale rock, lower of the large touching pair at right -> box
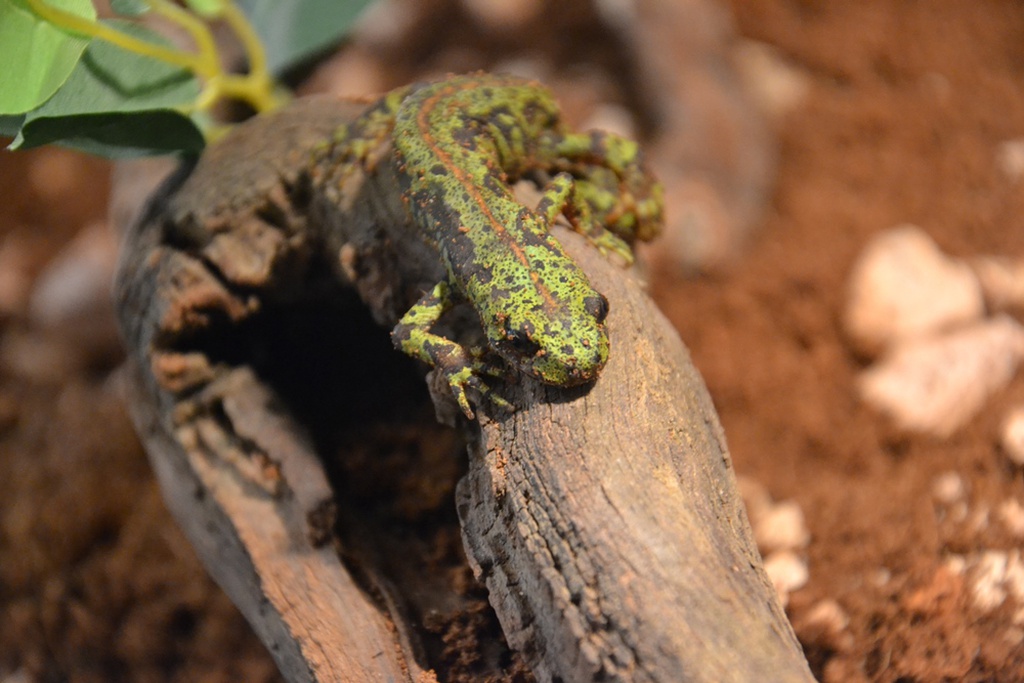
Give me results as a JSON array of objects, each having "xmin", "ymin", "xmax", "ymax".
[{"xmin": 857, "ymin": 315, "xmax": 1024, "ymax": 436}]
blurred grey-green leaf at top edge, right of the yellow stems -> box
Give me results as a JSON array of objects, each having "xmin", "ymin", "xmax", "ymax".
[{"xmin": 239, "ymin": 0, "xmax": 373, "ymax": 74}]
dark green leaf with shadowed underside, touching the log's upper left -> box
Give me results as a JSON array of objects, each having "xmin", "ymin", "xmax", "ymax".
[{"xmin": 9, "ymin": 22, "xmax": 203, "ymax": 158}]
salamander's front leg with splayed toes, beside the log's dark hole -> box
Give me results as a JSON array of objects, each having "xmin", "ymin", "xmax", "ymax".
[{"xmin": 391, "ymin": 282, "xmax": 514, "ymax": 420}]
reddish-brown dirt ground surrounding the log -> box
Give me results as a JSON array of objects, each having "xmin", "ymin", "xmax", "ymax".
[{"xmin": 6, "ymin": 0, "xmax": 1024, "ymax": 682}]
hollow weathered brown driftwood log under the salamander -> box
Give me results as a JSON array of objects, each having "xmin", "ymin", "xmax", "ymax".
[{"xmin": 117, "ymin": 93, "xmax": 812, "ymax": 681}]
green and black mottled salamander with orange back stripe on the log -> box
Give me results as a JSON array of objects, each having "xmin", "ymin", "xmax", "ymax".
[{"xmin": 325, "ymin": 74, "xmax": 662, "ymax": 417}]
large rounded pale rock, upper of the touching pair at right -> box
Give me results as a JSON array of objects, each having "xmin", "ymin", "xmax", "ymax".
[{"xmin": 844, "ymin": 225, "xmax": 985, "ymax": 355}]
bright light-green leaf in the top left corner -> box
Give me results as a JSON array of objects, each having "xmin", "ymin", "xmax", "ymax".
[{"xmin": 0, "ymin": 0, "xmax": 96, "ymax": 114}]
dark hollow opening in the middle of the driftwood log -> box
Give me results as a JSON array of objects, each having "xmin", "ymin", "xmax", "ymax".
[{"xmin": 159, "ymin": 252, "xmax": 528, "ymax": 680}]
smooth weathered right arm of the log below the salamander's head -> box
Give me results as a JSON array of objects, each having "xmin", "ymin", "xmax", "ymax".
[{"xmin": 459, "ymin": 234, "xmax": 811, "ymax": 682}]
